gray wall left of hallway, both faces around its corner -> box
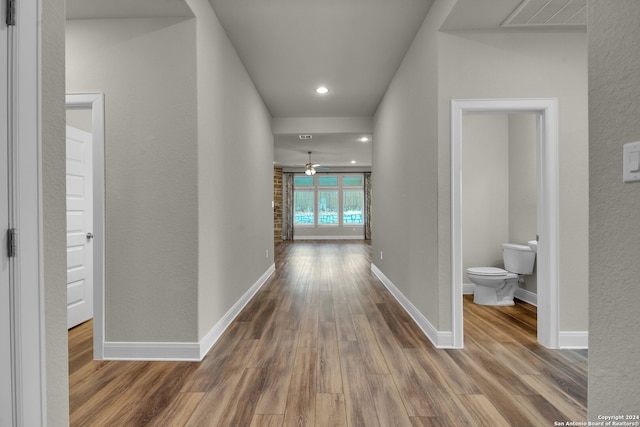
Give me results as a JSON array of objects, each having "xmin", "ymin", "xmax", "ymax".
[{"xmin": 67, "ymin": 0, "xmax": 273, "ymax": 342}]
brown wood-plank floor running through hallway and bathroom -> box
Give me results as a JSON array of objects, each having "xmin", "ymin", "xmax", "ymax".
[{"xmin": 69, "ymin": 242, "xmax": 587, "ymax": 427}]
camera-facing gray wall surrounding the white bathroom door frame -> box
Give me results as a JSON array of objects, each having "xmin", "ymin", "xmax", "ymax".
[{"xmin": 438, "ymin": 27, "xmax": 589, "ymax": 331}]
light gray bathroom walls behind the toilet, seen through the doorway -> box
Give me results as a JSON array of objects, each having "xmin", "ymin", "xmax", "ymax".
[{"xmin": 461, "ymin": 113, "xmax": 538, "ymax": 306}]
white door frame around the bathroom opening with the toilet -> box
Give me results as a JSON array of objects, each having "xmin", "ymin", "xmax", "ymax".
[{"xmin": 451, "ymin": 99, "xmax": 560, "ymax": 348}]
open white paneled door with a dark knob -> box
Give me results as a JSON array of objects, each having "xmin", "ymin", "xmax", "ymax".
[{"xmin": 67, "ymin": 126, "xmax": 93, "ymax": 328}]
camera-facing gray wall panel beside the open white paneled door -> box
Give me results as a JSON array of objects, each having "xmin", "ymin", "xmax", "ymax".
[{"xmin": 66, "ymin": 18, "xmax": 198, "ymax": 342}]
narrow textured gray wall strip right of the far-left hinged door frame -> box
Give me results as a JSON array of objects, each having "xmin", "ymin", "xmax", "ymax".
[{"xmin": 40, "ymin": 0, "xmax": 69, "ymax": 427}]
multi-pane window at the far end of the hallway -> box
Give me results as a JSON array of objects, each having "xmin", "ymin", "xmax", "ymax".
[{"xmin": 293, "ymin": 174, "xmax": 364, "ymax": 227}]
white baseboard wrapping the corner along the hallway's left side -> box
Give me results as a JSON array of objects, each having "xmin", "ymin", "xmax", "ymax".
[{"xmin": 104, "ymin": 264, "xmax": 276, "ymax": 362}]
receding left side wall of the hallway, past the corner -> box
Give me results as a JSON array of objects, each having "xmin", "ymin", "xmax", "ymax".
[{"xmin": 187, "ymin": 0, "xmax": 273, "ymax": 339}]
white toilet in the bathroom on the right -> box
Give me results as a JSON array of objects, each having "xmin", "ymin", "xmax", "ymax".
[{"xmin": 467, "ymin": 243, "xmax": 536, "ymax": 305}]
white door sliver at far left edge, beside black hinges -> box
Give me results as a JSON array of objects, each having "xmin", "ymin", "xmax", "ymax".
[{"xmin": 0, "ymin": 10, "xmax": 13, "ymax": 426}]
